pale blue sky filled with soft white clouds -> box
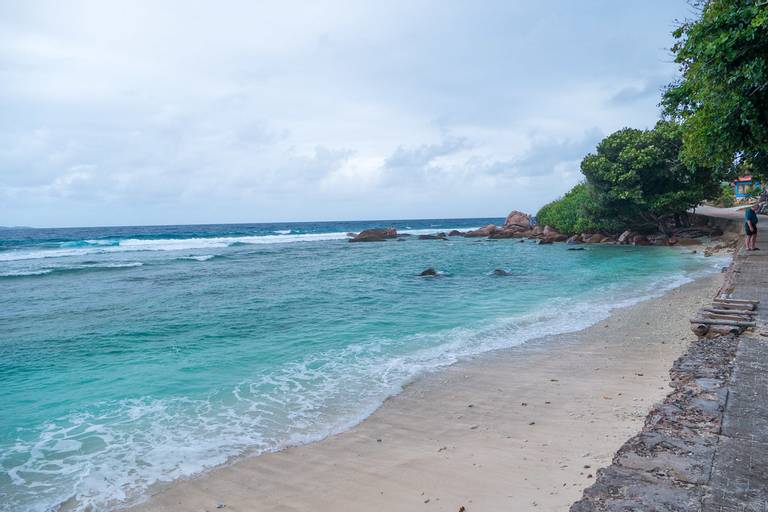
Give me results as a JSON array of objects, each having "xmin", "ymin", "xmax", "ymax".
[{"xmin": 0, "ymin": 0, "xmax": 692, "ymax": 226}]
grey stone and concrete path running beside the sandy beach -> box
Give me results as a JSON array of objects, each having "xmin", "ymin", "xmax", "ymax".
[{"xmin": 571, "ymin": 207, "xmax": 768, "ymax": 512}]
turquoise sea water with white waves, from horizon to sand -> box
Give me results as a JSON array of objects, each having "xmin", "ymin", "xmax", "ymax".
[{"xmin": 0, "ymin": 219, "xmax": 720, "ymax": 511}]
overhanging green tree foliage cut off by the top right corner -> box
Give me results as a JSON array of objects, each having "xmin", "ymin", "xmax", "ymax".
[{"xmin": 662, "ymin": 0, "xmax": 768, "ymax": 179}]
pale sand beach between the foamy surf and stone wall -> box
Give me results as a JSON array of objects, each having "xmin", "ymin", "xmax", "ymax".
[{"xmin": 126, "ymin": 275, "xmax": 722, "ymax": 512}]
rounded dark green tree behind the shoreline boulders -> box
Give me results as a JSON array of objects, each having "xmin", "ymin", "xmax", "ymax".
[{"xmin": 581, "ymin": 121, "xmax": 720, "ymax": 230}]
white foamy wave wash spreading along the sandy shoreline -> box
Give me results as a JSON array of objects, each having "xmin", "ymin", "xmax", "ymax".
[{"xmin": 0, "ymin": 260, "xmax": 721, "ymax": 512}]
